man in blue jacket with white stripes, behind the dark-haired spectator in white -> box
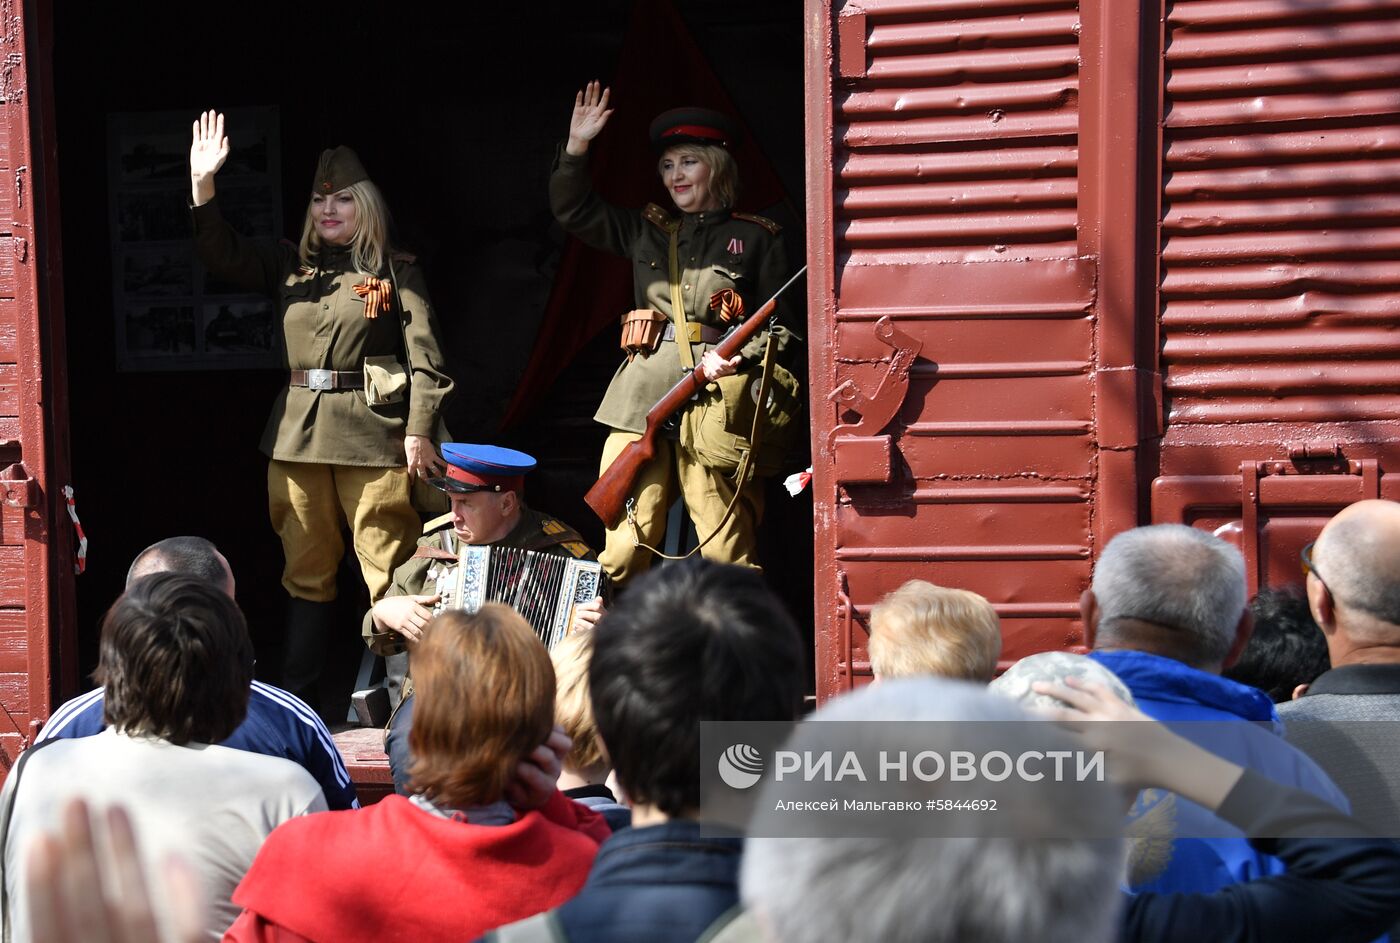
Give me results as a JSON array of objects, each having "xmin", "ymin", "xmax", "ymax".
[{"xmin": 35, "ymin": 537, "xmax": 360, "ymax": 809}]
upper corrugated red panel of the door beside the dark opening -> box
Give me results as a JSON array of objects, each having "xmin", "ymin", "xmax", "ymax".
[{"xmin": 834, "ymin": 0, "xmax": 1079, "ymax": 264}]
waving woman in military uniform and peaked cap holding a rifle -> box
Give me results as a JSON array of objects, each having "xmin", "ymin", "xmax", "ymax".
[{"xmin": 549, "ymin": 83, "xmax": 795, "ymax": 585}]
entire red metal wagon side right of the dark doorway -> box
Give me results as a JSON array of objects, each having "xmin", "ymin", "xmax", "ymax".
[{"xmin": 806, "ymin": 0, "xmax": 1400, "ymax": 695}]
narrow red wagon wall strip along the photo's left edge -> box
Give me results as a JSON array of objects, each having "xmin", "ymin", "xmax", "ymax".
[{"xmin": 0, "ymin": 0, "xmax": 73, "ymax": 770}]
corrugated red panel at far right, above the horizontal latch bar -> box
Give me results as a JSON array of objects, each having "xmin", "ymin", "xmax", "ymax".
[{"xmin": 1161, "ymin": 0, "xmax": 1400, "ymax": 444}]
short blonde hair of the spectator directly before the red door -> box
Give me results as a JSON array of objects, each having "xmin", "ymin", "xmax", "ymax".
[{"xmin": 869, "ymin": 579, "xmax": 1001, "ymax": 681}]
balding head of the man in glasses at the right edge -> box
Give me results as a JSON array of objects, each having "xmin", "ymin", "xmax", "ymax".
[{"xmin": 1312, "ymin": 501, "xmax": 1400, "ymax": 642}]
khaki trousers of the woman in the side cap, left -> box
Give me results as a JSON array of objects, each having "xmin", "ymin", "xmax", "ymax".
[{"xmin": 267, "ymin": 459, "xmax": 423, "ymax": 603}]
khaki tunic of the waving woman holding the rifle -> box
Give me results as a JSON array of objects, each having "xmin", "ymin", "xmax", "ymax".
[{"xmin": 549, "ymin": 150, "xmax": 795, "ymax": 432}]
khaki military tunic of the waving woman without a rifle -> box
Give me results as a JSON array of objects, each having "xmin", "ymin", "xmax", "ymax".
[{"xmin": 193, "ymin": 200, "xmax": 452, "ymax": 467}]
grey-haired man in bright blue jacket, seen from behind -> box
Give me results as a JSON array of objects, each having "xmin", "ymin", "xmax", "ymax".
[{"xmin": 1079, "ymin": 525, "xmax": 1350, "ymax": 893}]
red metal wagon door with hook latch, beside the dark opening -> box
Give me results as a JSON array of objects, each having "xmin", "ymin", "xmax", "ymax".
[{"xmin": 808, "ymin": 0, "xmax": 1138, "ymax": 697}]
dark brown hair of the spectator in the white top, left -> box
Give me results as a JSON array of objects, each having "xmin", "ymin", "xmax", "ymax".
[{"xmin": 94, "ymin": 574, "xmax": 253, "ymax": 744}]
